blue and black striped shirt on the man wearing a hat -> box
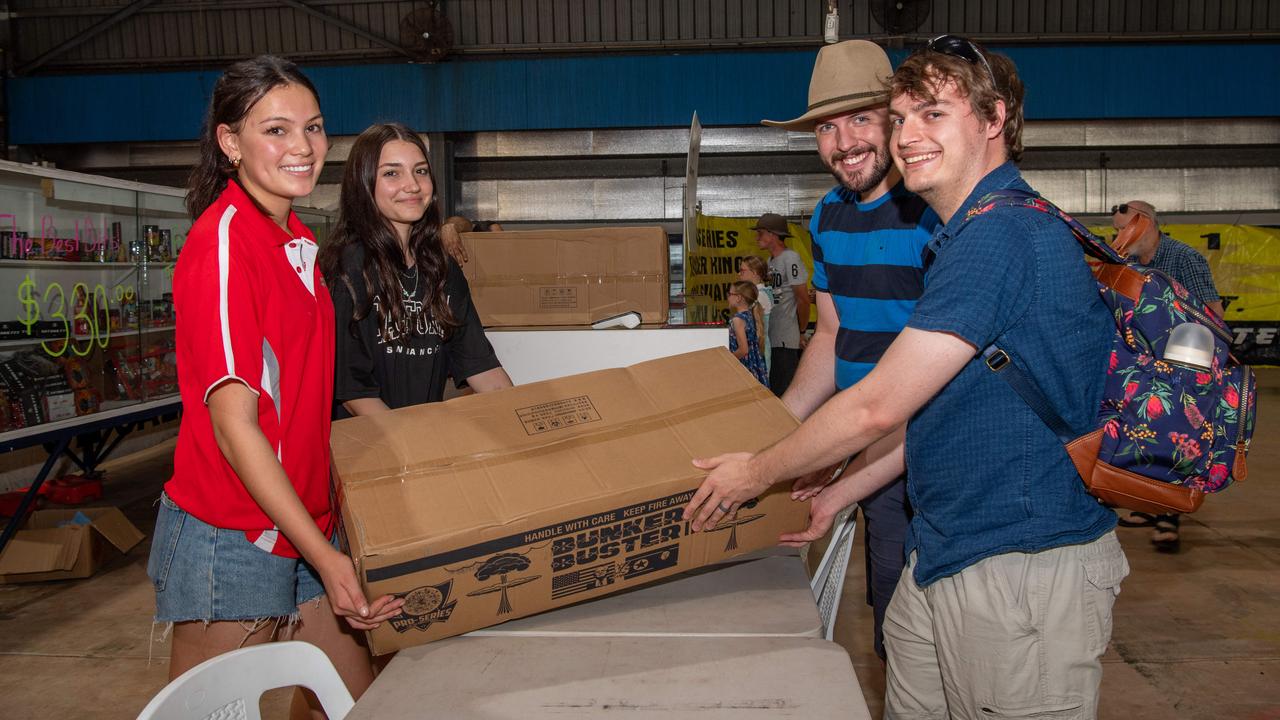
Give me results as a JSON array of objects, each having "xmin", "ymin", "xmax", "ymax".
[{"xmin": 809, "ymin": 182, "xmax": 941, "ymax": 389}]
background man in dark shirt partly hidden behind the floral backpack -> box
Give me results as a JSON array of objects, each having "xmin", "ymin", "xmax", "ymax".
[{"xmin": 1111, "ymin": 200, "xmax": 1224, "ymax": 552}]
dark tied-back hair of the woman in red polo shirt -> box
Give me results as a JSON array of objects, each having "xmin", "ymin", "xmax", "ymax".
[{"xmin": 187, "ymin": 55, "xmax": 320, "ymax": 219}]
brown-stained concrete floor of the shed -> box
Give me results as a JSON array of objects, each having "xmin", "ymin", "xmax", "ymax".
[{"xmin": 0, "ymin": 370, "xmax": 1280, "ymax": 720}]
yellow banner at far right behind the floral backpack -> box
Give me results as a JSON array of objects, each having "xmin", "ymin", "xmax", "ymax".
[{"xmin": 1089, "ymin": 225, "xmax": 1280, "ymax": 365}]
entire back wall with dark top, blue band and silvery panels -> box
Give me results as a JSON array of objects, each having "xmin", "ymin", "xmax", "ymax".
[{"xmin": 8, "ymin": 0, "xmax": 1280, "ymax": 224}]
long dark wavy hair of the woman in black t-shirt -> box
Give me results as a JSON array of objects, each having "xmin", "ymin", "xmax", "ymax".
[{"xmin": 320, "ymin": 123, "xmax": 458, "ymax": 336}]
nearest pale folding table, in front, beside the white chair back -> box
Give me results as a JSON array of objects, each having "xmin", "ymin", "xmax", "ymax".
[{"xmin": 347, "ymin": 635, "xmax": 870, "ymax": 720}]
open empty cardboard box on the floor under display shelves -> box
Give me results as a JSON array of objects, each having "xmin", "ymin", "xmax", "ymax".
[{"xmin": 0, "ymin": 507, "xmax": 146, "ymax": 584}]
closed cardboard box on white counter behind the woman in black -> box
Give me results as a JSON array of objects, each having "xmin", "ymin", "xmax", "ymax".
[{"xmin": 462, "ymin": 225, "xmax": 671, "ymax": 327}]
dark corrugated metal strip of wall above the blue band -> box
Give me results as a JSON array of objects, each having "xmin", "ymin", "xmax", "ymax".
[{"xmin": 9, "ymin": 0, "xmax": 1280, "ymax": 74}]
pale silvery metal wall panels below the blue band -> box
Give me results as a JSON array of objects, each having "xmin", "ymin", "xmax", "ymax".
[{"xmin": 452, "ymin": 119, "xmax": 1280, "ymax": 223}]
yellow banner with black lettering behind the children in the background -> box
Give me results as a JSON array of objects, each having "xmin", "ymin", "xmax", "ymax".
[{"xmin": 685, "ymin": 214, "xmax": 817, "ymax": 324}]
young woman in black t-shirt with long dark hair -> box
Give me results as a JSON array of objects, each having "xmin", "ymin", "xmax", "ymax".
[{"xmin": 320, "ymin": 123, "xmax": 511, "ymax": 418}]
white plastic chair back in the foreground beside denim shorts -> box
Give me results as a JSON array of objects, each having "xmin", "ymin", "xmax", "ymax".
[{"xmin": 138, "ymin": 641, "xmax": 356, "ymax": 720}]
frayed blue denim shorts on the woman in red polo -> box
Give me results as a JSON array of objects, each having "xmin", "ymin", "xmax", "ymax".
[{"xmin": 147, "ymin": 493, "xmax": 338, "ymax": 623}]
